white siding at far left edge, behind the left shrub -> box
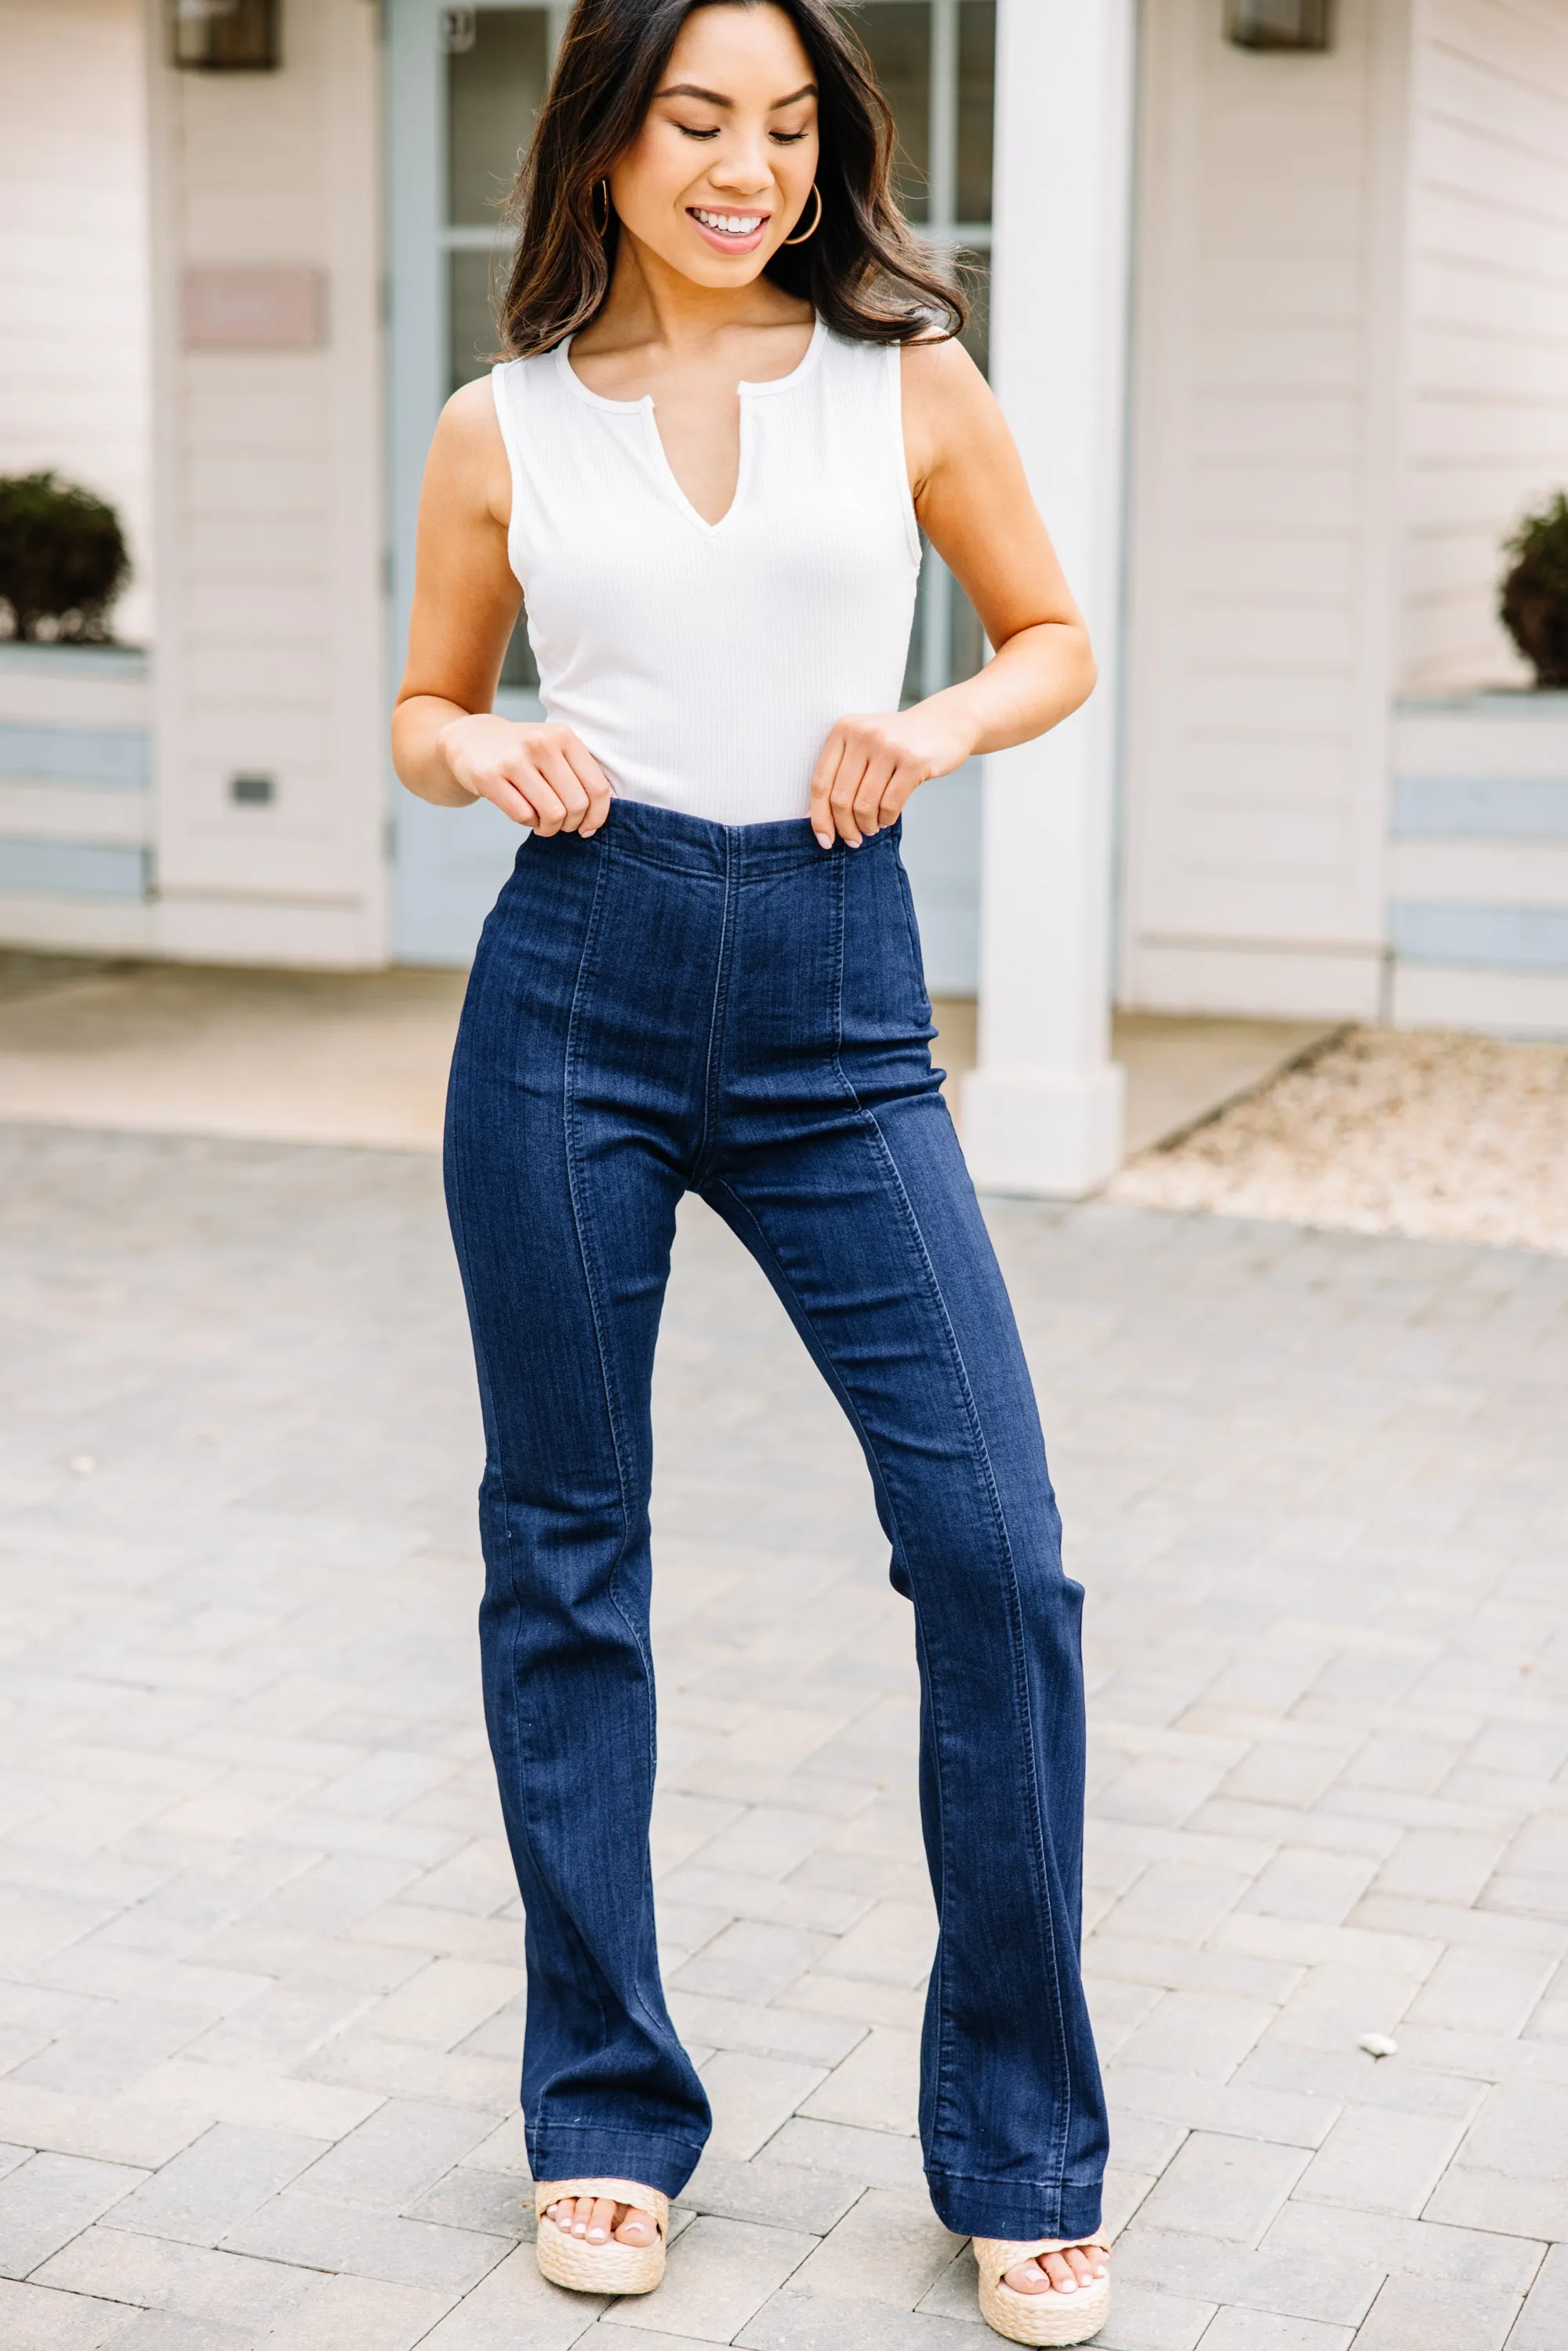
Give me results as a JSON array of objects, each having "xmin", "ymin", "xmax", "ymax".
[{"xmin": 0, "ymin": 0, "xmax": 153, "ymax": 642}]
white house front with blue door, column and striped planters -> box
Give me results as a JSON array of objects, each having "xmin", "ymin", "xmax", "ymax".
[{"xmin": 0, "ymin": 0, "xmax": 1568, "ymax": 1192}]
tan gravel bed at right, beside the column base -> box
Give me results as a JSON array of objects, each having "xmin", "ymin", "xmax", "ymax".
[{"xmin": 1109, "ymin": 1028, "xmax": 1568, "ymax": 1255}]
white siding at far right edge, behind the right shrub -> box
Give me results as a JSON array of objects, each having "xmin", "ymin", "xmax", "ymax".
[{"xmin": 1401, "ymin": 0, "xmax": 1568, "ymax": 691}]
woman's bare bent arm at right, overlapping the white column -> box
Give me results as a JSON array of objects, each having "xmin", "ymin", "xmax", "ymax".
[{"xmin": 811, "ymin": 326, "xmax": 1095, "ymax": 844}]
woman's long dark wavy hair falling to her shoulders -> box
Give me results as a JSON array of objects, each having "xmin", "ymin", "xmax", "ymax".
[{"xmin": 501, "ymin": 0, "xmax": 968, "ymax": 360}]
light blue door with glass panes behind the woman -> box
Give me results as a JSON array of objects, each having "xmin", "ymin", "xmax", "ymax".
[{"xmin": 388, "ymin": 0, "xmax": 996, "ymax": 973}]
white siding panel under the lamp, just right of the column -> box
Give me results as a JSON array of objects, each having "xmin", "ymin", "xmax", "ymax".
[{"xmin": 1121, "ymin": 0, "xmax": 1406, "ymax": 1014}]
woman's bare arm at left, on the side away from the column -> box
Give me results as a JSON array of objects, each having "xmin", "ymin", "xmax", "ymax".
[{"xmin": 393, "ymin": 383, "xmax": 612, "ymax": 835}]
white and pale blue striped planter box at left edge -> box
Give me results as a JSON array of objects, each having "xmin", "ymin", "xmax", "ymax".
[{"xmin": 0, "ymin": 644, "xmax": 153, "ymax": 952}]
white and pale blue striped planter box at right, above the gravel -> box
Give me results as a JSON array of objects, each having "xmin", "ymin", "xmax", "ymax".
[{"xmin": 1387, "ymin": 691, "xmax": 1568, "ymax": 1037}]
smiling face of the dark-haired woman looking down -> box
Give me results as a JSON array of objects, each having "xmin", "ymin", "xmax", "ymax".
[{"xmin": 609, "ymin": 0, "xmax": 818, "ymax": 287}]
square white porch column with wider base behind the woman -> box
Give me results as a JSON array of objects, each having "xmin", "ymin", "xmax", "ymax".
[{"xmin": 964, "ymin": 0, "xmax": 1135, "ymax": 1199}]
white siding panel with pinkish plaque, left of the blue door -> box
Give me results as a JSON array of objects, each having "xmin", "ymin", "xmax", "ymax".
[{"xmin": 153, "ymin": 0, "xmax": 388, "ymax": 964}]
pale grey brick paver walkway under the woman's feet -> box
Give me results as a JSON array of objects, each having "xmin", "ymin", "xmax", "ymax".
[{"xmin": 0, "ymin": 1131, "xmax": 1568, "ymax": 2351}]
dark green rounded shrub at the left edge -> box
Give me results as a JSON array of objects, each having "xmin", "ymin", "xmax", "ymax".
[{"xmin": 0, "ymin": 473, "xmax": 132, "ymax": 644}]
